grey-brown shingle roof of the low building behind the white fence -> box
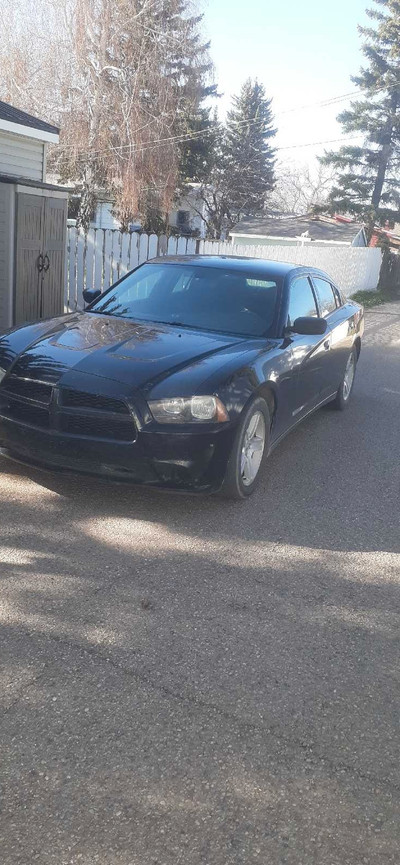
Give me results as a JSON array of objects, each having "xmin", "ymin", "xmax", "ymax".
[{"xmin": 231, "ymin": 216, "xmax": 363, "ymax": 243}]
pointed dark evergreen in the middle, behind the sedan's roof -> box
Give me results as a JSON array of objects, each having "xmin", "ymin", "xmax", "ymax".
[{"xmin": 224, "ymin": 79, "xmax": 276, "ymax": 221}]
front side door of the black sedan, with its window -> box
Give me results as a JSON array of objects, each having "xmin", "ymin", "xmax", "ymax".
[{"xmin": 287, "ymin": 275, "xmax": 331, "ymax": 423}]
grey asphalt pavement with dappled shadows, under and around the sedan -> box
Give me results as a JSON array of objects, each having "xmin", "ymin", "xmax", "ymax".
[{"xmin": 0, "ymin": 304, "xmax": 400, "ymax": 865}]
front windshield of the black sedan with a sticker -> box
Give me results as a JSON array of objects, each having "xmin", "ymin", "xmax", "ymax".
[{"xmin": 91, "ymin": 263, "xmax": 279, "ymax": 337}]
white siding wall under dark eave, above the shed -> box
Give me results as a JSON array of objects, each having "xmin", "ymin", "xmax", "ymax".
[{"xmin": 0, "ymin": 130, "xmax": 45, "ymax": 180}]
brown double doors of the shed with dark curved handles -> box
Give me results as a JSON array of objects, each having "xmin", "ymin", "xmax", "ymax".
[{"xmin": 14, "ymin": 192, "xmax": 67, "ymax": 324}]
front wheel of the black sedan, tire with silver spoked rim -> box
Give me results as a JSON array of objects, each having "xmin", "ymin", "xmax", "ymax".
[{"xmin": 221, "ymin": 397, "xmax": 271, "ymax": 500}]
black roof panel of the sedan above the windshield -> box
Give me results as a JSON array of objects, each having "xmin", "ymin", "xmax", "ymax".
[{"xmin": 145, "ymin": 255, "xmax": 329, "ymax": 279}]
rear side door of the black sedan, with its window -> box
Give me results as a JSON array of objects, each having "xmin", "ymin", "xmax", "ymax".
[{"xmin": 312, "ymin": 275, "xmax": 353, "ymax": 400}]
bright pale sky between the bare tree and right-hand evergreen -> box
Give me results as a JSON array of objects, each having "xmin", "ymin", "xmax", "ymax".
[{"xmin": 203, "ymin": 0, "xmax": 373, "ymax": 165}]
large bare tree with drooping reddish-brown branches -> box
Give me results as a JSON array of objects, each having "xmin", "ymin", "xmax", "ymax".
[{"xmin": 0, "ymin": 0, "xmax": 216, "ymax": 228}]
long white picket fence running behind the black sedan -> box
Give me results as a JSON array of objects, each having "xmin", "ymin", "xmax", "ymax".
[{"xmin": 64, "ymin": 228, "xmax": 382, "ymax": 312}]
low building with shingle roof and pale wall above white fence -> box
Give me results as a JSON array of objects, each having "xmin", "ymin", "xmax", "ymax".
[{"xmin": 230, "ymin": 215, "xmax": 368, "ymax": 246}]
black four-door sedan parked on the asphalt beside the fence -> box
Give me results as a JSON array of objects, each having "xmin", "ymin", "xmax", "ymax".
[{"xmin": 0, "ymin": 256, "xmax": 364, "ymax": 498}]
